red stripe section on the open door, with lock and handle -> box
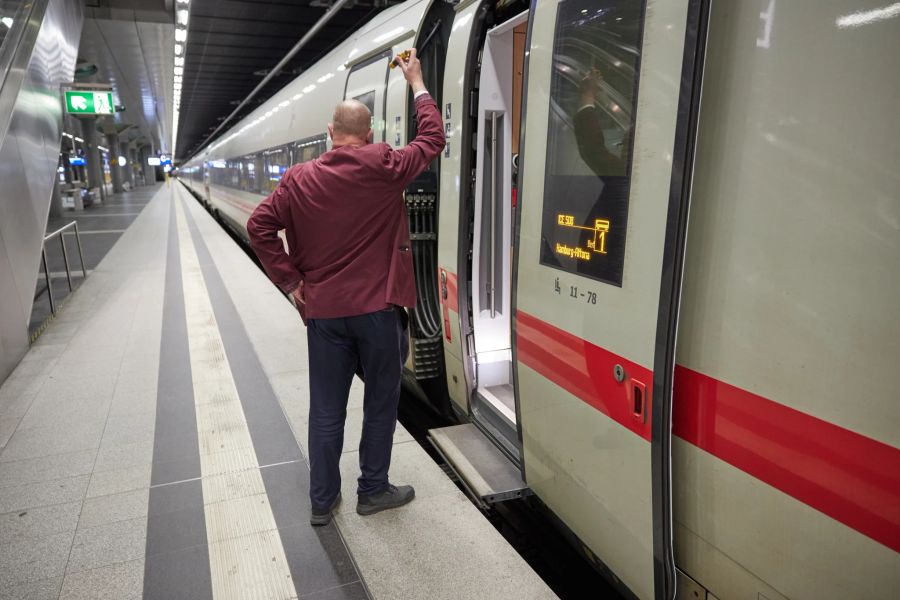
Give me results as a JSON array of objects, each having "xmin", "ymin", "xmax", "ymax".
[{"xmin": 516, "ymin": 311, "xmax": 653, "ymax": 441}]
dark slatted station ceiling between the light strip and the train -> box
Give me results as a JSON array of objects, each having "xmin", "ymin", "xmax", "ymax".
[{"xmin": 176, "ymin": 0, "xmax": 399, "ymax": 160}]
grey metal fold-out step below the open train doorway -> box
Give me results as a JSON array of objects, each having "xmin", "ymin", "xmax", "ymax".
[{"xmin": 428, "ymin": 423, "xmax": 531, "ymax": 509}]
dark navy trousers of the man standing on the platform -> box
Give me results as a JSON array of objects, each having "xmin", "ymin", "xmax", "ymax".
[{"xmin": 307, "ymin": 308, "xmax": 409, "ymax": 512}]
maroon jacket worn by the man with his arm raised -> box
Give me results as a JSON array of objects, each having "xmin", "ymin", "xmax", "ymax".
[{"xmin": 247, "ymin": 94, "xmax": 444, "ymax": 321}]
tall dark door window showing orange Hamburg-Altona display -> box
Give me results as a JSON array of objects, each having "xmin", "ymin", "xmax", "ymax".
[{"xmin": 540, "ymin": 0, "xmax": 644, "ymax": 286}]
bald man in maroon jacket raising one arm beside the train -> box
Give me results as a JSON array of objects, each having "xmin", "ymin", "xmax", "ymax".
[{"xmin": 247, "ymin": 50, "xmax": 444, "ymax": 525}]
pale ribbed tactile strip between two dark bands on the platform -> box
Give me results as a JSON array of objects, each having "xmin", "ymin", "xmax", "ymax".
[{"xmin": 172, "ymin": 194, "xmax": 297, "ymax": 600}]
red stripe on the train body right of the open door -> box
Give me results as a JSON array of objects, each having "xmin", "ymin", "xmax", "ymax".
[{"xmin": 673, "ymin": 366, "xmax": 900, "ymax": 551}]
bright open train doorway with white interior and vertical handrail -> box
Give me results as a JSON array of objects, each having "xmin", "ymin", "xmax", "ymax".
[{"xmin": 467, "ymin": 12, "xmax": 528, "ymax": 457}]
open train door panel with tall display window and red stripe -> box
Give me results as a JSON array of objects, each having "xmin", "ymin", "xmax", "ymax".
[{"xmin": 513, "ymin": 0, "xmax": 707, "ymax": 598}]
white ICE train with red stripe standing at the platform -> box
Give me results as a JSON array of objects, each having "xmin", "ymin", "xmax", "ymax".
[{"xmin": 177, "ymin": 0, "xmax": 900, "ymax": 600}]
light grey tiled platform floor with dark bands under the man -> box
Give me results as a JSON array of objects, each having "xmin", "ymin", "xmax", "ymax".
[{"xmin": 0, "ymin": 182, "xmax": 554, "ymax": 600}]
